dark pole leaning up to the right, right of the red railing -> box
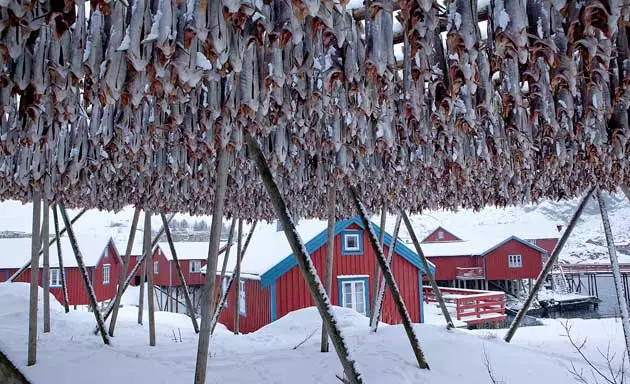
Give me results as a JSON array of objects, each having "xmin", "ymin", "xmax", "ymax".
[{"xmin": 504, "ymin": 188, "xmax": 594, "ymax": 343}]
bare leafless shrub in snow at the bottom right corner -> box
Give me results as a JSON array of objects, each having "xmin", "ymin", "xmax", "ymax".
[{"xmin": 560, "ymin": 320, "xmax": 626, "ymax": 384}]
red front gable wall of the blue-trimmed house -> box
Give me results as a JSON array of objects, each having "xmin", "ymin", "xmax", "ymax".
[{"xmin": 276, "ymin": 225, "xmax": 420, "ymax": 324}]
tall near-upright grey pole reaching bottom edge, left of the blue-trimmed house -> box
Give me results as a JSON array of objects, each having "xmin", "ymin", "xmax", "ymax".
[{"xmin": 195, "ymin": 148, "xmax": 229, "ymax": 384}]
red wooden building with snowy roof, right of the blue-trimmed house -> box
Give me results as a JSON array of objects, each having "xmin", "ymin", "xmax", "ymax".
[{"xmin": 421, "ymin": 226, "xmax": 558, "ymax": 288}]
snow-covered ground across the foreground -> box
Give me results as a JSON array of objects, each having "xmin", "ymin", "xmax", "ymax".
[{"xmin": 0, "ymin": 283, "xmax": 623, "ymax": 384}]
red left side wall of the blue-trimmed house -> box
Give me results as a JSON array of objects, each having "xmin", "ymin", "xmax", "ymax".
[{"xmin": 217, "ymin": 277, "xmax": 271, "ymax": 333}]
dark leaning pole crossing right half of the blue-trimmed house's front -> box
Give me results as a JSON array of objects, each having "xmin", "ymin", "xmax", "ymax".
[{"xmin": 350, "ymin": 187, "xmax": 430, "ymax": 369}]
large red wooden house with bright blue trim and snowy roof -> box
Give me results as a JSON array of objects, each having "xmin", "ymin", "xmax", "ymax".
[{"xmin": 203, "ymin": 217, "xmax": 434, "ymax": 332}]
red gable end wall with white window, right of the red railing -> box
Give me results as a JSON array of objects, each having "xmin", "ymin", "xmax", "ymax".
[{"xmin": 486, "ymin": 240, "xmax": 542, "ymax": 280}]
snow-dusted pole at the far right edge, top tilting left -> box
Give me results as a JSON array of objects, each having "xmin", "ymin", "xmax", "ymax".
[{"xmin": 596, "ymin": 188, "xmax": 630, "ymax": 359}]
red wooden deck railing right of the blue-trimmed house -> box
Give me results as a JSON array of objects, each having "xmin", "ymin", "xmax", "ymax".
[{"xmin": 422, "ymin": 286, "xmax": 505, "ymax": 324}]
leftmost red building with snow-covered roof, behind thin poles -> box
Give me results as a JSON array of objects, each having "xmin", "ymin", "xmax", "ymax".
[{"xmin": 0, "ymin": 236, "xmax": 121, "ymax": 305}]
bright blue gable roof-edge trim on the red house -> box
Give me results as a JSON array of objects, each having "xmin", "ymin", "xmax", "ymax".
[{"xmin": 260, "ymin": 216, "xmax": 435, "ymax": 288}]
